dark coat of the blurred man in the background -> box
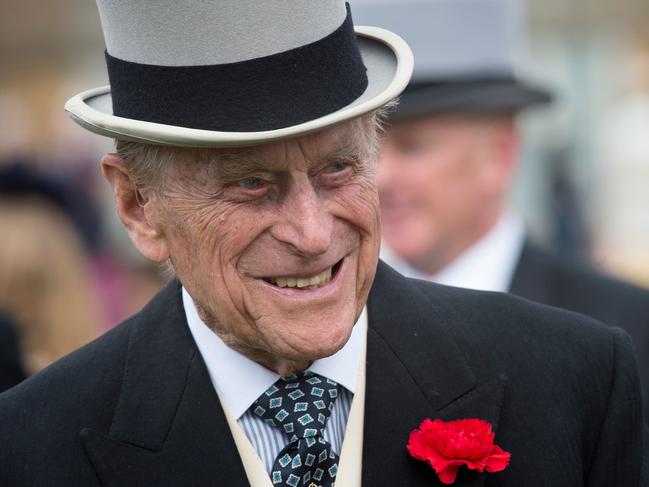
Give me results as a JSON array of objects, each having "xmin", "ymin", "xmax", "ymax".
[{"xmin": 509, "ymin": 241, "xmax": 649, "ymax": 424}]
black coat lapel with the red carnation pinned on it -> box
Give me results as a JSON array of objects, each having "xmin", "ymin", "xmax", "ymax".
[{"xmin": 363, "ymin": 263, "xmax": 506, "ymax": 487}]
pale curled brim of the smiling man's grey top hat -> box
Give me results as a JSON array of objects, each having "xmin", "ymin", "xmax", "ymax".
[{"xmin": 65, "ymin": 26, "xmax": 414, "ymax": 147}]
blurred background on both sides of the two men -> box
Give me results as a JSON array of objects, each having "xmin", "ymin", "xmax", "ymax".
[{"xmin": 0, "ymin": 0, "xmax": 649, "ymax": 371}]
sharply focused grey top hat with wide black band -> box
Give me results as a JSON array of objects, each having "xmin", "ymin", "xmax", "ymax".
[{"xmin": 65, "ymin": 0, "xmax": 413, "ymax": 147}]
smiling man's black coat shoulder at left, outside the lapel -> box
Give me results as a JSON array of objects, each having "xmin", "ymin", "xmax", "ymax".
[{"xmin": 0, "ymin": 319, "xmax": 133, "ymax": 486}]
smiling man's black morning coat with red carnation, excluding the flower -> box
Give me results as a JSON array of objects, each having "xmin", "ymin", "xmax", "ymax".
[{"xmin": 0, "ymin": 263, "xmax": 648, "ymax": 487}]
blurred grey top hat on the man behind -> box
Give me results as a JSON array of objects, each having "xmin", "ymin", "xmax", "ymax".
[{"xmin": 352, "ymin": 0, "xmax": 552, "ymax": 119}]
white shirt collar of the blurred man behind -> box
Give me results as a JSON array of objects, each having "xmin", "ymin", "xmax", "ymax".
[{"xmin": 381, "ymin": 213, "xmax": 525, "ymax": 292}]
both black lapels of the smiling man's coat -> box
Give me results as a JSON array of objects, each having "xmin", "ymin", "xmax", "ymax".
[{"xmin": 81, "ymin": 263, "xmax": 504, "ymax": 487}]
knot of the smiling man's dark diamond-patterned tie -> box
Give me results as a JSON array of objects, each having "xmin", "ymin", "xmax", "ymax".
[{"xmin": 251, "ymin": 372, "xmax": 338, "ymax": 441}]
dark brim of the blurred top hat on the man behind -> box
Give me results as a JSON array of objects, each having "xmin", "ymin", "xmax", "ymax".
[{"xmin": 390, "ymin": 79, "xmax": 552, "ymax": 120}]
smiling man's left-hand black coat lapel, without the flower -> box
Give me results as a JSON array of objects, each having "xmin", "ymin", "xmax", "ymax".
[{"xmin": 81, "ymin": 281, "xmax": 248, "ymax": 487}]
